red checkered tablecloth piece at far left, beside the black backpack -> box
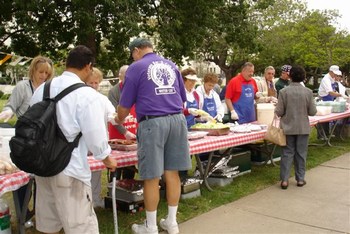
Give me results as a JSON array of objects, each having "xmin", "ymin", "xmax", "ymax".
[{"xmin": 0, "ymin": 171, "xmax": 30, "ymax": 197}]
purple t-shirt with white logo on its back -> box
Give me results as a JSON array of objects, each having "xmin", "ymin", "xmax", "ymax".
[{"xmin": 119, "ymin": 53, "xmax": 186, "ymax": 121}]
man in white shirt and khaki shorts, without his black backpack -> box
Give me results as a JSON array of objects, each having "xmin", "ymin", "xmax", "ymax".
[{"xmin": 31, "ymin": 46, "xmax": 117, "ymax": 233}]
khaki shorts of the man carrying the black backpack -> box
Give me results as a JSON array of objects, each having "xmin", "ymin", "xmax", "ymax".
[{"xmin": 35, "ymin": 172, "xmax": 99, "ymax": 234}]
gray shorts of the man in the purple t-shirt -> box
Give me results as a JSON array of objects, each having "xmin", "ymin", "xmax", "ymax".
[{"xmin": 137, "ymin": 114, "xmax": 192, "ymax": 179}]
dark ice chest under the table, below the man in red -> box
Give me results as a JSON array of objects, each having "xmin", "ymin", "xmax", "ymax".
[{"xmin": 227, "ymin": 148, "xmax": 252, "ymax": 176}]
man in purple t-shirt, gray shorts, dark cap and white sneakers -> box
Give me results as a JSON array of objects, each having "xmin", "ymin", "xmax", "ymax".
[{"xmin": 115, "ymin": 38, "xmax": 191, "ymax": 233}]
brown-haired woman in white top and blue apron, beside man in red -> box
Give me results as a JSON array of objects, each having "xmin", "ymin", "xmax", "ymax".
[{"xmin": 196, "ymin": 73, "xmax": 224, "ymax": 122}]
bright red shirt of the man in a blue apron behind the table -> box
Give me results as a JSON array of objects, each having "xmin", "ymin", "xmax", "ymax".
[{"xmin": 225, "ymin": 74, "xmax": 258, "ymax": 103}]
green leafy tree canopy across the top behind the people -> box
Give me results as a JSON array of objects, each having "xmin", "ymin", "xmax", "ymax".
[{"xmin": 0, "ymin": 0, "xmax": 350, "ymax": 86}]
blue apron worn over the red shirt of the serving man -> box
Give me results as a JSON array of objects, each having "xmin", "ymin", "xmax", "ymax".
[{"xmin": 232, "ymin": 84, "xmax": 256, "ymax": 124}]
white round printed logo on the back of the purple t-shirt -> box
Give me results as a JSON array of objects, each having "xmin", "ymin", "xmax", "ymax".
[{"xmin": 147, "ymin": 61, "xmax": 176, "ymax": 95}]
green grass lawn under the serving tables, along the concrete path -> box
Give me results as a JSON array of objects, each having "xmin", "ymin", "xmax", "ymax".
[{"xmin": 0, "ymin": 99, "xmax": 350, "ymax": 234}]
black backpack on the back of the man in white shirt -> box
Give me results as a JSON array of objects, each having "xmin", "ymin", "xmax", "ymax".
[{"xmin": 10, "ymin": 80, "xmax": 87, "ymax": 177}]
